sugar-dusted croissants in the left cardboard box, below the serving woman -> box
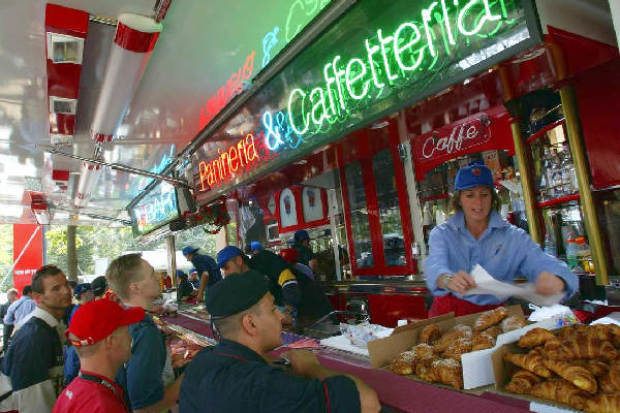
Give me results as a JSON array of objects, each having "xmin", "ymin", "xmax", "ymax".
[{"xmin": 389, "ymin": 307, "xmax": 526, "ymax": 389}]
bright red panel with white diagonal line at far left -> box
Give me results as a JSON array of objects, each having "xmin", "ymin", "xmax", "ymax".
[{"xmin": 13, "ymin": 224, "xmax": 43, "ymax": 293}]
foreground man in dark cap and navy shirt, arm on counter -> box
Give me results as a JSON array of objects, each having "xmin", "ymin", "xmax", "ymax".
[{"xmin": 179, "ymin": 270, "xmax": 381, "ymax": 413}]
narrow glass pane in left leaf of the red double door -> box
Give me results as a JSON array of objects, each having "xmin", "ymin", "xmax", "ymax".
[{"xmin": 345, "ymin": 162, "xmax": 374, "ymax": 268}]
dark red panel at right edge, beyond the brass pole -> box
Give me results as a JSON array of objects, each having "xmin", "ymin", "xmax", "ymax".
[{"xmin": 574, "ymin": 58, "xmax": 620, "ymax": 189}]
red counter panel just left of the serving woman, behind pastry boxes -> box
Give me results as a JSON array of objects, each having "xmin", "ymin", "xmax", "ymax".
[{"xmin": 368, "ymin": 294, "xmax": 428, "ymax": 327}]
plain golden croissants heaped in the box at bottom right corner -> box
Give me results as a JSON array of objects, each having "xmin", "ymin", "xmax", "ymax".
[{"xmin": 504, "ymin": 324, "xmax": 620, "ymax": 413}]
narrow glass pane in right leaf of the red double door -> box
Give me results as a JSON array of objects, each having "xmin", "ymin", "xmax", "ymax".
[{"xmin": 372, "ymin": 149, "xmax": 407, "ymax": 267}]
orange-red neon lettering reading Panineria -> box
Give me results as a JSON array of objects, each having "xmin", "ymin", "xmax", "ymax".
[{"xmin": 198, "ymin": 133, "xmax": 260, "ymax": 191}]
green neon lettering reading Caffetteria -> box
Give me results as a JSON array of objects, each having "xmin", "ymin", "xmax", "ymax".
[{"xmin": 287, "ymin": 0, "xmax": 507, "ymax": 135}]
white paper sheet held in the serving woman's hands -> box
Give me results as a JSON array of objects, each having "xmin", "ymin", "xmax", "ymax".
[{"xmin": 467, "ymin": 264, "xmax": 564, "ymax": 305}]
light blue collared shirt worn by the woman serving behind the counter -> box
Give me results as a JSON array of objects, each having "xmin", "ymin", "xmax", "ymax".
[{"xmin": 424, "ymin": 211, "xmax": 579, "ymax": 305}]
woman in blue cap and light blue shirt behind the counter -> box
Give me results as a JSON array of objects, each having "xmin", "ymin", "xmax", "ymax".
[{"xmin": 425, "ymin": 163, "xmax": 578, "ymax": 317}]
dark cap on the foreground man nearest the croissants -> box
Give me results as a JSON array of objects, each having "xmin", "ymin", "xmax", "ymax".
[{"xmin": 205, "ymin": 268, "xmax": 269, "ymax": 318}]
